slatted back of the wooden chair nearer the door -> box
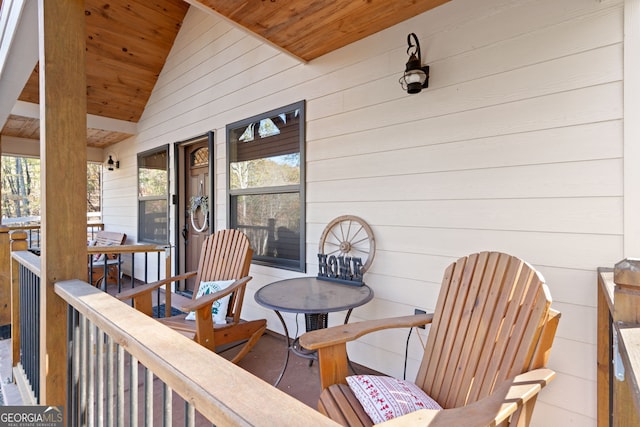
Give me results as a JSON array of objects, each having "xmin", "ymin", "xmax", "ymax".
[{"xmin": 193, "ymin": 230, "xmax": 253, "ymax": 322}]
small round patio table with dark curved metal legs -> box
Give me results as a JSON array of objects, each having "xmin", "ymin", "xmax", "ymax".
[{"xmin": 254, "ymin": 277, "xmax": 373, "ymax": 386}]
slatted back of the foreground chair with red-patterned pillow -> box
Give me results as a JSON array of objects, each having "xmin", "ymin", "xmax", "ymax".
[{"xmin": 416, "ymin": 252, "xmax": 551, "ymax": 408}]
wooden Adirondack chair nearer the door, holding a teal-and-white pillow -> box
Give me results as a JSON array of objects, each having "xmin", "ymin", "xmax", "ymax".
[{"xmin": 116, "ymin": 230, "xmax": 267, "ymax": 363}]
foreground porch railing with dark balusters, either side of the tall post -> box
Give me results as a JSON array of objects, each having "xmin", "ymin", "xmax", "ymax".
[{"xmin": 7, "ymin": 247, "xmax": 337, "ymax": 426}]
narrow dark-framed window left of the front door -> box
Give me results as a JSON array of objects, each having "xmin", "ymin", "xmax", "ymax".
[{"xmin": 138, "ymin": 145, "xmax": 169, "ymax": 244}]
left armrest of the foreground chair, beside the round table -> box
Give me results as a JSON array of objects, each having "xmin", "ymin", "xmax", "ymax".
[{"xmin": 300, "ymin": 313, "xmax": 433, "ymax": 350}]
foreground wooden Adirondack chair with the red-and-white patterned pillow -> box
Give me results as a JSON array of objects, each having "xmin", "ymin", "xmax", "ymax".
[{"xmin": 300, "ymin": 252, "xmax": 560, "ymax": 426}]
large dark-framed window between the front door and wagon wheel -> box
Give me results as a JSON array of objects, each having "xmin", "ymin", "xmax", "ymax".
[{"xmin": 227, "ymin": 101, "xmax": 305, "ymax": 272}]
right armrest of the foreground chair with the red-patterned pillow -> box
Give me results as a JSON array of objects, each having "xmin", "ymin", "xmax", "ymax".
[{"xmin": 376, "ymin": 368, "xmax": 555, "ymax": 427}]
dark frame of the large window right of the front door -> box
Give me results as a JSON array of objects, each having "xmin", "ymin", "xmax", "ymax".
[{"xmin": 225, "ymin": 100, "xmax": 306, "ymax": 273}]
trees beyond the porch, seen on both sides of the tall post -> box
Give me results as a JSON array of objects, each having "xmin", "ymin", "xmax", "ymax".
[{"xmin": 2, "ymin": 156, "xmax": 102, "ymax": 222}]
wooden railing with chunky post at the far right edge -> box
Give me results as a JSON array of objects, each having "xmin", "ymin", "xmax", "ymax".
[{"xmin": 597, "ymin": 261, "xmax": 640, "ymax": 427}]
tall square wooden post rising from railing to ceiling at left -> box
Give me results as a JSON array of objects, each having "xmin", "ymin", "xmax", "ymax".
[{"xmin": 38, "ymin": 0, "xmax": 87, "ymax": 408}]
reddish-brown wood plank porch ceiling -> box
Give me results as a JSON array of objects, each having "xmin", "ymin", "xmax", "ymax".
[{"xmin": 0, "ymin": 0, "xmax": 449, "ymax": 147}]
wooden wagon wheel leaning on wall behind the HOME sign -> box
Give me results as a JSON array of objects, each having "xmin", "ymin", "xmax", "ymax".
[{"xmin": 318, "ymin": 215, "xmax": 376, "ymax": 273}]
